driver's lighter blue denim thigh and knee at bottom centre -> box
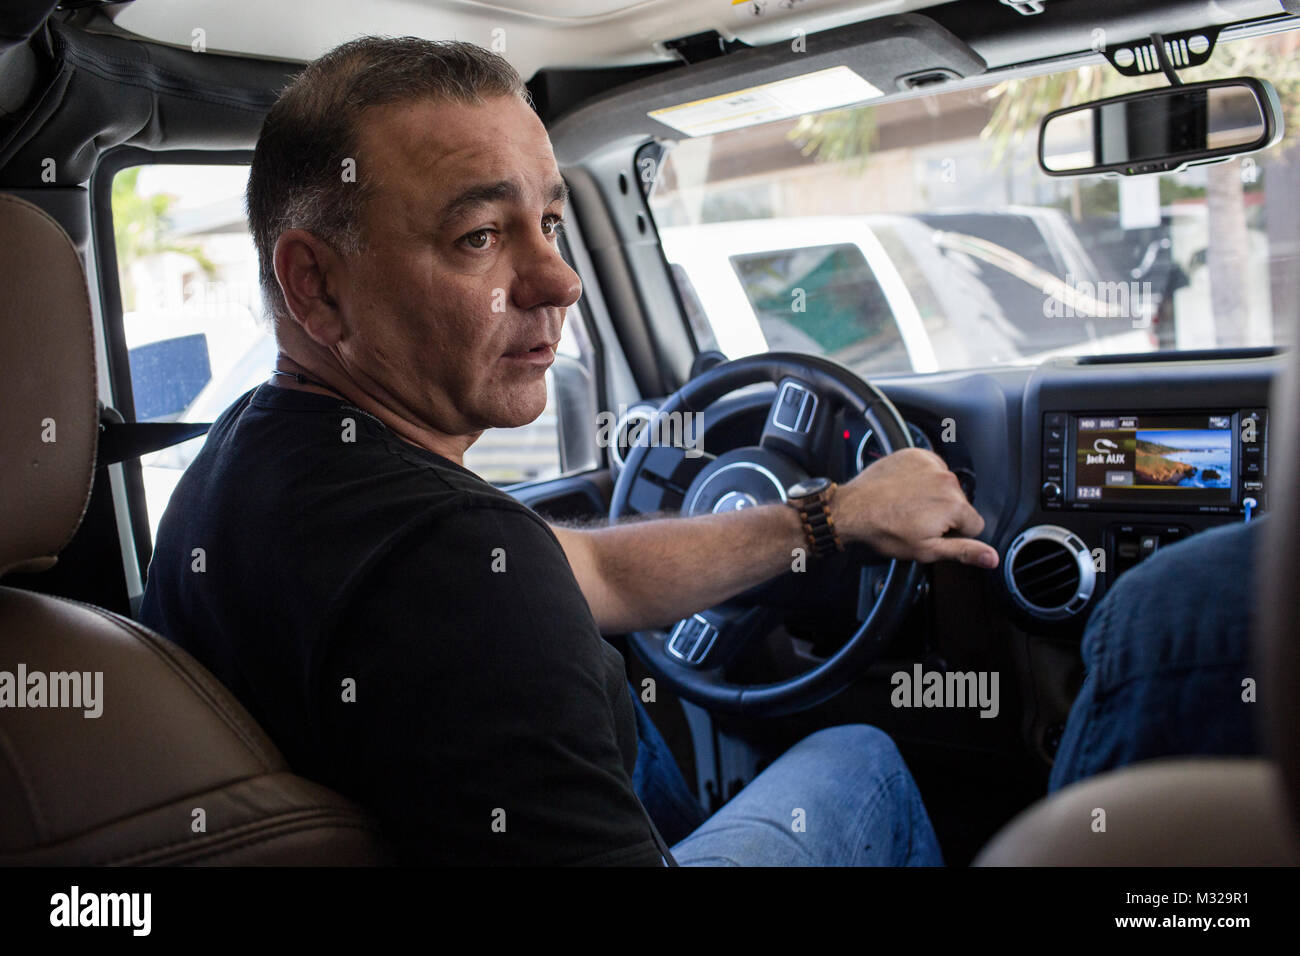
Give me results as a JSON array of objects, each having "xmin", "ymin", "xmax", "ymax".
[{"xmin": 672, "ymin": 723, "xmax": 944, "ymax": 866}]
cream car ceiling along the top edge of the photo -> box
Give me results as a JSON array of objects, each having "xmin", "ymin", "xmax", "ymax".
[{"xmin": 101, "ymin": 0, "xmax": 1300, "ymax": 78}]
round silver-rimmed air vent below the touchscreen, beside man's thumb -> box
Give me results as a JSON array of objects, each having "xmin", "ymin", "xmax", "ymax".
[{"xmin": 1002, "ymin": 524, "xmax": 1097, "ymax": 620}]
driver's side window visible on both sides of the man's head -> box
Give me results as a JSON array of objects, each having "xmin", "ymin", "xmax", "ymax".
[{"xmin": 112, "ymin": 164, "xmax": 594, "ymax": 533}]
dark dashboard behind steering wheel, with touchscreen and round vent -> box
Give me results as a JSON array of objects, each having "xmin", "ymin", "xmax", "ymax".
[{"xmin": 615, "ymin": 354, "xmax": 1283, "ymax": 633}]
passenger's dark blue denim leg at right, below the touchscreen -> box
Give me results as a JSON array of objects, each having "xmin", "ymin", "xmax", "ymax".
[{"xmin": 1048, "ymin": 520, "xmax": 1262, "ymax": 792}]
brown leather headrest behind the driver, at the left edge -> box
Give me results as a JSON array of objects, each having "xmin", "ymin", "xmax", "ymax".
[{"xmin": 0, "ymin": 194, "xmax": 99, "ymax": 575}]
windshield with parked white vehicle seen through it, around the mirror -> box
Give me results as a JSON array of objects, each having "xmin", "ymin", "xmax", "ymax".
[{"xmin": 650, "ymin": 24, "xmax": 1300, "ymax": 373}]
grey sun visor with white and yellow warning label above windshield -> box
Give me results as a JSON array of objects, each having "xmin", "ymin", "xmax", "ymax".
[{"xmin": 550, "ymin": 13, "xmax": 985, "ymax": 165}]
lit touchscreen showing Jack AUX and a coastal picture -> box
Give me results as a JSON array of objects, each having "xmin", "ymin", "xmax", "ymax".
[{"xmin": 1074, "ymin": 412, "xmax": 1234, "ymax": 505}]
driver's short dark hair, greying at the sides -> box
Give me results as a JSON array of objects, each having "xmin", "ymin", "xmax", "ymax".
[{"xmin": 246, "ymin": 36, "xmax": 532, "ymax": 323}]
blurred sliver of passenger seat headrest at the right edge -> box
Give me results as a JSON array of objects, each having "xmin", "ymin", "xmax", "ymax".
[{"xmin": 1258, "ymin": 347, "xmax": 1300, "ymax": 832}]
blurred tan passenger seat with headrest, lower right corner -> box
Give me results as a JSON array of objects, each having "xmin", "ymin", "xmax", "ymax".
[{"xmin": 975, "ymin": 349, "xmax": 1300, "ymax": 866}]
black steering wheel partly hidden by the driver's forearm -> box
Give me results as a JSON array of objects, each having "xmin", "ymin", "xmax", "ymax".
[{"xmin": 610, "ymin": 352, "xmax": 922, "ymax": 717}]
